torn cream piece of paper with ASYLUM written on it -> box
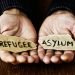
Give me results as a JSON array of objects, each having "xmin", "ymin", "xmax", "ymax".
[{"xmin": 38, "ymin": 34, "xmax": 75, "ymax": 50}]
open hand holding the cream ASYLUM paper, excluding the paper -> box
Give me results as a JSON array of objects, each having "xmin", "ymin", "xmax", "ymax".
[{"xmin": 38, "ymin": 10, "xmax": 75, "ymax": 64}]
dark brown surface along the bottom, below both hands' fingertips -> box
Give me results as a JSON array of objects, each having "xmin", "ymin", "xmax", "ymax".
[{"xmin": 0, "ymin": 62, "xmax": 75, "ymax": 75}]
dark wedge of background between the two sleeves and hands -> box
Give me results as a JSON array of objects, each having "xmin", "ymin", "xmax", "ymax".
[{"xmin": 31, "ymin": 0, "xmax": 52, "ymax": 32}]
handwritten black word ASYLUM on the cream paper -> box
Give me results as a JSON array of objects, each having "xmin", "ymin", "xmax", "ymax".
[{"xmin": 42, "ymin": 39, "xmax": 74, "ymax": 47}]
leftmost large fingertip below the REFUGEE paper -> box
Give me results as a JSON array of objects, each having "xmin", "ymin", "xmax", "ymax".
[{"xmin": 0, "ymin": 50, "xmax": 15, "ymax": 63}]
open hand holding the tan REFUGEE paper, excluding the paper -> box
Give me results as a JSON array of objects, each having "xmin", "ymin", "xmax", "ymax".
[{"xmin": 0, "ymin": 9, "xmax": 39, "ymax": 64}]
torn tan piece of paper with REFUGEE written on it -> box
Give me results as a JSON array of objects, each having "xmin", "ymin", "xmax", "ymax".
[{"xmin": 0, "ymin": 35, "xmax": 36, "ymax": 53}]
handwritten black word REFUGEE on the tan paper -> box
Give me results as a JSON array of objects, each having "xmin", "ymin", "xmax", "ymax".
[{"xmin": 0, "ymin": 41, "xmax": 32, "ymax": 48}]
